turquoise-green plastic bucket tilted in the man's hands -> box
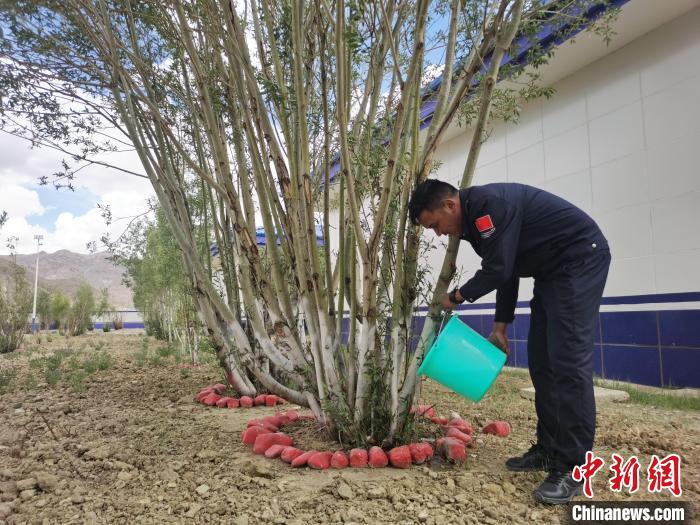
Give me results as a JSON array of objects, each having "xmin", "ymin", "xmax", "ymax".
[{"xmin": 418, "ymin": 316, "xmax": 506, "ymax": 402}]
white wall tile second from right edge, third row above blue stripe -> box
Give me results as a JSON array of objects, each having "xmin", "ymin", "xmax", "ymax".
[{"xmin": 591, "ymin": 150, "xmax": 649, "ymax": 211}]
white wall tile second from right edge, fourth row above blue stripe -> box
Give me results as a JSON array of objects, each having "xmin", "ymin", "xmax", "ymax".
[{"xmin": 589, "ymin": 102, "xmax": 644, "ymax": 166}]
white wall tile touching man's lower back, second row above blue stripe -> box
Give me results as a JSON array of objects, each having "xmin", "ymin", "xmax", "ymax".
[{"xmin": 595, "ymin": 204, "xmax": 653, "ymax": 260}]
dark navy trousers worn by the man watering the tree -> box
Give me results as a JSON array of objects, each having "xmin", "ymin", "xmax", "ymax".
[{"xmin": 527, "ymin": 249, "xmax": 610, "ymax": 470}]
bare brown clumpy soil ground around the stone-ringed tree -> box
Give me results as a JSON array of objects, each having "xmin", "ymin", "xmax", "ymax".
[{"xmin": 0, "ymin": 332, "xmax": 700, "ymax": 524}]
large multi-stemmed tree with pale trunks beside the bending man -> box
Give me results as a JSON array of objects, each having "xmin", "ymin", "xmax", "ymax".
[{"xmin": 0, "ymin": 0, "xmax": 616, "ymax": 444}]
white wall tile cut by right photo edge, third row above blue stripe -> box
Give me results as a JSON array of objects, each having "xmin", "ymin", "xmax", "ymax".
[{"xmin": 646, "ymin": 133, "xmax": 700, "ymax": 199}]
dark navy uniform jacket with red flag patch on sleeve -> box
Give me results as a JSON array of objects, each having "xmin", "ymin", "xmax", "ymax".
[{"xmin": 459, "ymin": 183, "xmax": 608, "ymax": 323}]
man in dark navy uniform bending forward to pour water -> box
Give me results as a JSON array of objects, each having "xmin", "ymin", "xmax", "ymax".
[{"xmin": 409, "ymin": 180, "xmax": 610, "ymax": 504}]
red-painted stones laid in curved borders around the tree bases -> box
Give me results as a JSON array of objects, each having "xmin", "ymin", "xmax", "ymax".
[{"xmin": 195, "ymin": 383, "xmax": 511, "ymax": 470}]
